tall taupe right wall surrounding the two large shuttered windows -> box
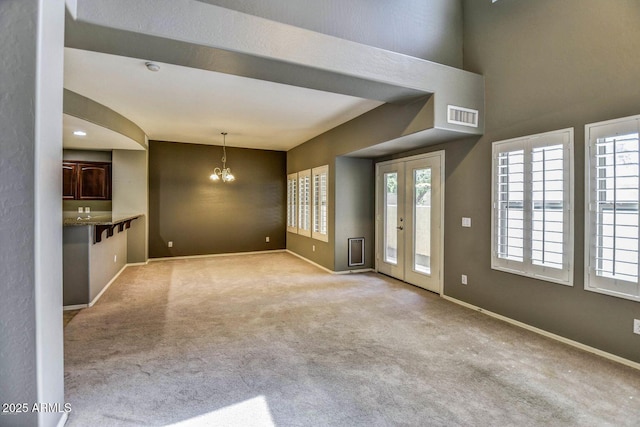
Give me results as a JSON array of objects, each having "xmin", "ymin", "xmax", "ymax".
[{"xmin": 424, "ymin": 0, "xmax": 640, "ymax": 362}]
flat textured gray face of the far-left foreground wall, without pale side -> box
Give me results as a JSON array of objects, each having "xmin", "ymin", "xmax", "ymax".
[{"xmin": 0, "ymin": 0, "xmax": 37, "ymax": 426}]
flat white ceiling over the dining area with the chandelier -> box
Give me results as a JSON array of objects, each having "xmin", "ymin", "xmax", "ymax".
[{"xmin": 64, "ymin": 48, "xmax": 382, "ymax": 150}]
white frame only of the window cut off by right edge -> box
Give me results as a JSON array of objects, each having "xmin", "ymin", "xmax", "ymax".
[{"xmin": 584, "ymin": 115, "xmax": 640, "ymax": 301}]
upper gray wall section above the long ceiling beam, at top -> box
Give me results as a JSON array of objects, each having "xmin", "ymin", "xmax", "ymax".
[{"xmin": 198, "ymin": 0, "xmax": 462, "ymax": 68}]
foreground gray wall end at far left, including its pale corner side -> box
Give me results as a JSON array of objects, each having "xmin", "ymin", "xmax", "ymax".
[{"xmin": 0, "ymin": 0, "xmax": 64, "ymax": 426}]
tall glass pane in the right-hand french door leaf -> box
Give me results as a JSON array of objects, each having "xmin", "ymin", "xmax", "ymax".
[{"xmin": 413, "ymin": 168, "xmax": 431, "ymax": 274}]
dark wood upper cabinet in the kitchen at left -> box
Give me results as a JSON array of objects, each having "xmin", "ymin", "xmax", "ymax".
[{"xmin": 62, "ymin": 161, "xmax": 111, "ymax": 200}]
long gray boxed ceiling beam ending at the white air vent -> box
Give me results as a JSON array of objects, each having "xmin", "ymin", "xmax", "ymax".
[{"xmin": 65, "ymin": 0, "xmax": 484, "ymax": 134}]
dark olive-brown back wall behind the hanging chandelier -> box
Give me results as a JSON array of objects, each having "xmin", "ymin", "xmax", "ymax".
[{"xmin": 149, "ymin": 141, "xmax": 286, "ymax": 258}]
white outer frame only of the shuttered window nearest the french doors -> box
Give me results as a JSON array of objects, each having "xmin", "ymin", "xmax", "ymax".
[{"xmin": 491, "ymin": 128, "xmax": 574, "ymax": 286}]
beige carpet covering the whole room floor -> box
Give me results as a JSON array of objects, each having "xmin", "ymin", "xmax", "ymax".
[{"xmin": 65, "ymin": 253, "xmax": 640, "ymax": 427}]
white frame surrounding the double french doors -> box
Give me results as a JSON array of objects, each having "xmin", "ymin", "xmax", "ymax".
[{"xmin": 375, "ymin": 150, "xmax": 445, "ymax": 295}]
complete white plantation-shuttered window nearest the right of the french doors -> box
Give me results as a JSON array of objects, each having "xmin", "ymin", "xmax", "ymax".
[{"xmin": 491, "ymin": 129, "xmax": 573, "ymax": 285}]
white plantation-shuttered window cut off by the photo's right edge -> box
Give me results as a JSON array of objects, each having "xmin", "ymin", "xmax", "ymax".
[{"xmin": 585, "ymin": 116, "xmax": 640, "ymax": 301}]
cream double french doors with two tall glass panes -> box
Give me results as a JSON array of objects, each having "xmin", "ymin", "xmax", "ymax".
[{"xmin": 376, "ymin": 151, "xmax": 444, "ymax": 293}]
